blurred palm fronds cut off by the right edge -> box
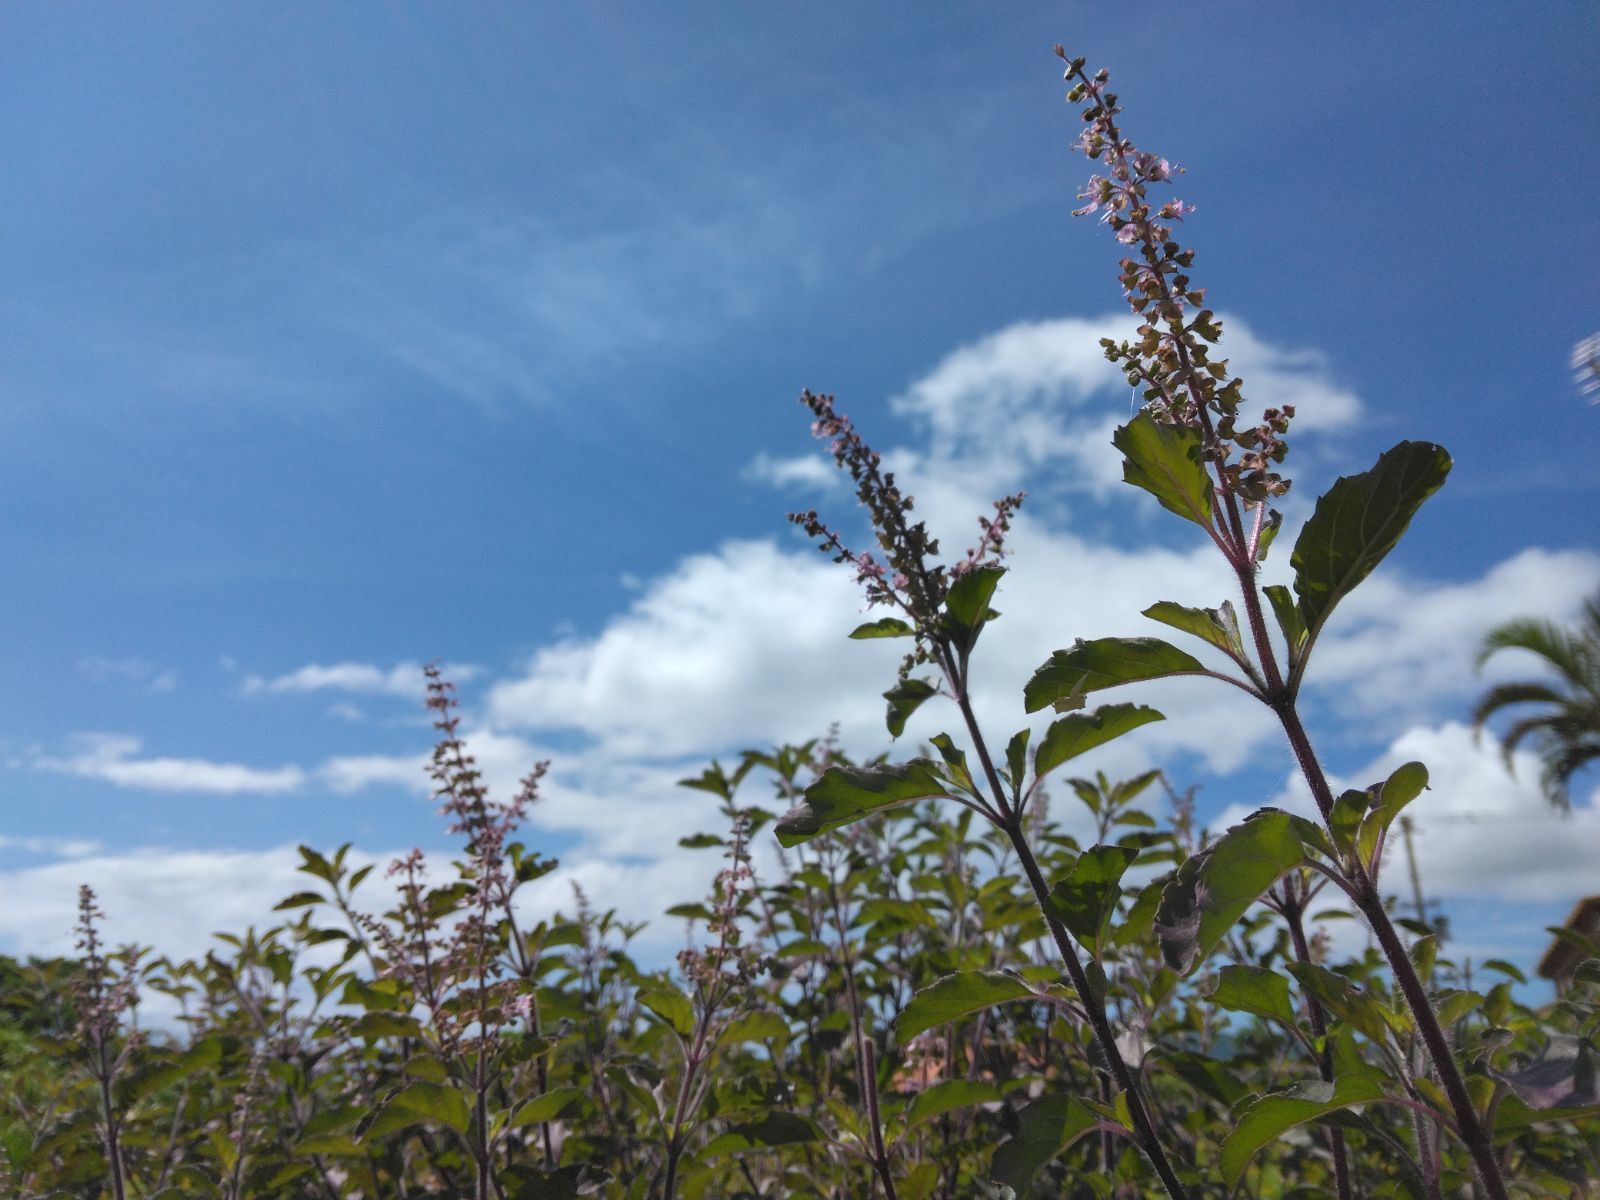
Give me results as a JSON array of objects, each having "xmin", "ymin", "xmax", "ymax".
[{"xmin": 1472, "ymin": 595, "xmax": 1600, "ymax": 811}]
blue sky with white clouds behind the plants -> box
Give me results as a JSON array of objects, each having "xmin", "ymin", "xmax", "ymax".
[{"xmin": 0, "ymin": 3, "xmax": 1600, "ymax": 979}]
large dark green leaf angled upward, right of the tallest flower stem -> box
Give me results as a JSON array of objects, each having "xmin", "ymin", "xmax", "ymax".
[{"xmin": 1290, "ymin": 442, "xmax": 1450, "ymax": 650}]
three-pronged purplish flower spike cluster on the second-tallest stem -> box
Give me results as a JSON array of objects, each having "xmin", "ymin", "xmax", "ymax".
[{"xmin": 789, "ymin": 390, "xmax": 1026, "ymax": 677}]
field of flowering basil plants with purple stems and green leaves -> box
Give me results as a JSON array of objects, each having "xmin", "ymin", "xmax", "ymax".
[{"xmin": 0, "ymin": 53, "xmax": 1600, "ymax": 1200}]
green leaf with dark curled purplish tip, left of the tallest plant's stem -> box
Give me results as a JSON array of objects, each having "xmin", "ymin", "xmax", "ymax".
[{"xmin": 1155, "ymin": 808, "xmax": 1310, "ymax": 974}]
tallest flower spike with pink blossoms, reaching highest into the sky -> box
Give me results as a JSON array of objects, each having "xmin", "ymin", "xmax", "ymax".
[{"xmin": 1056, "ymin": 46, "xmax": 1294, "ymax": 504}]
